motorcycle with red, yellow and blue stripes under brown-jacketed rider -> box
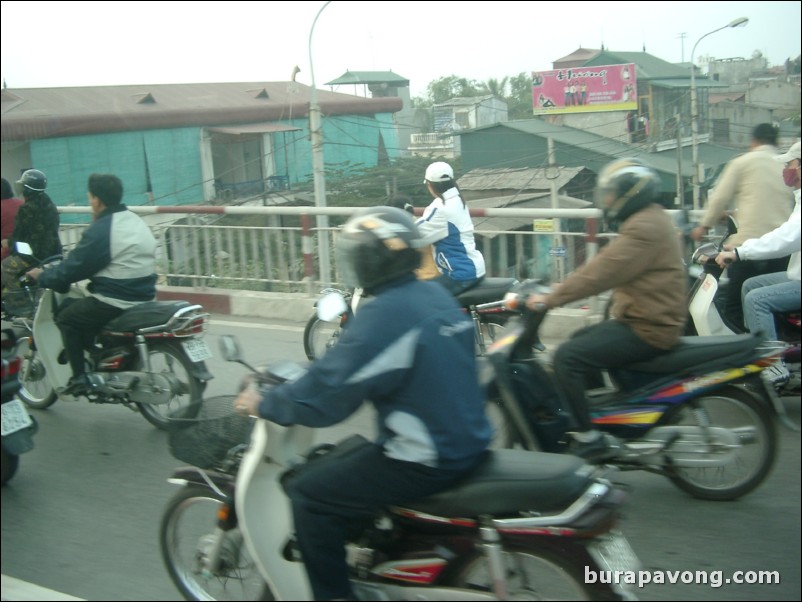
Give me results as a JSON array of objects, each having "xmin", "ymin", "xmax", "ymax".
[{"xmin": 478, "ymin": 281, "xmax": 790, "ymax": 500}]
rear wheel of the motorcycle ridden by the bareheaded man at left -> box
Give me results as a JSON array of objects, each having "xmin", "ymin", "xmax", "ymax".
[{"xmin": 134, "ymin": 343, "xmax": 206, "ymax": 430}]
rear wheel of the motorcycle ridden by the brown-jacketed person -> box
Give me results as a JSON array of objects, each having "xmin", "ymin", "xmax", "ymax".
[{"xmin": 668, "ymin": 386, "xmax": 777, "ymax": 501}]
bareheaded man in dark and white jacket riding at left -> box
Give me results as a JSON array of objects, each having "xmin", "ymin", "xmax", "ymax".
[{"xmin": 28, "ymin": 173, "xmax": 157, "ymax": 395}]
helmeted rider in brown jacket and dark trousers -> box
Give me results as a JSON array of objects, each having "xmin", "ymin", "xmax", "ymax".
[{"xmin": 526, "ymin": 158, "xmax": 687, "ymax": 462}]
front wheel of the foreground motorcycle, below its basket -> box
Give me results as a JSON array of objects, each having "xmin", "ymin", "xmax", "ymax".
[{"xmin": 159, "ymin": 485, "xmax": 275, "ymax": 600}]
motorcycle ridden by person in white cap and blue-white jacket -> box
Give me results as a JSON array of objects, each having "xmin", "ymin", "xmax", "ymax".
[{"xmin": 303, "ymin": 278, "xmax": 518, "ymax": 360}]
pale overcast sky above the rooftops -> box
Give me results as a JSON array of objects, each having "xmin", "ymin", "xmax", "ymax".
[{"xmin": 0, "ymin": 0, "xmax": 802, "ymax": 96}]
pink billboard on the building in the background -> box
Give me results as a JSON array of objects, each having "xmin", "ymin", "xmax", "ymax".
[{"xmin": 532, "ymin": 63, "xmax": 638, "ymax": 115}]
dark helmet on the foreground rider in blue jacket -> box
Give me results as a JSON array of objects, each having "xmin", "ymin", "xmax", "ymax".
[{"xmin": 336, "ymin": 206, "xmax": 421, "ymax": 289}]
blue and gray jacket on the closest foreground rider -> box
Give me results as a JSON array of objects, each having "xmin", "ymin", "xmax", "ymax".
[{"xmin": 259, "ymin": 275, "xmax": 490, "ymax": 470}]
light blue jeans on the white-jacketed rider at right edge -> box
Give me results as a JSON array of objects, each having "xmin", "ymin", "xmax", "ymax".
[{"xmin": 741, "ymin": 272, "xmax": 800, "ymax": 341}]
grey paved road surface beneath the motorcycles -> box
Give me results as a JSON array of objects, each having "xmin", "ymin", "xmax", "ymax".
[{"xmin": 1, "ymin": 316, "xmax": 802, "ymax": 600}]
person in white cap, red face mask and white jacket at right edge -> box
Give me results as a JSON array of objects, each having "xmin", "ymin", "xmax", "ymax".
[{"xmin": 716, "ymin": 142, "xmax": 802, "ymax": 386}]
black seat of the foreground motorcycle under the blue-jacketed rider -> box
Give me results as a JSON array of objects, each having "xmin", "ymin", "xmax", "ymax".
[{"xmin": 396, "ymin": 449, "xmax": 592, "ymax": 518}]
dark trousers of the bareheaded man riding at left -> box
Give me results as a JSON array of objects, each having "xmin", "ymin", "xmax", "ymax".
[{"xmin": 56, "ymin": 297, "xmax": 125, "ymax": 376}]
